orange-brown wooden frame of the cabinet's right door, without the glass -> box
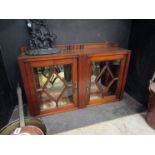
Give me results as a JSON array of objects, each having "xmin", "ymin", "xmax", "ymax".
[{"xmin": 86, "ymin": 54, "xmax": 129, "ymax": 106}]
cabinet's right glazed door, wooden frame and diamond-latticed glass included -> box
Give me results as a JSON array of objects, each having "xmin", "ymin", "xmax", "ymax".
[{"xmin": 86, "ymin": 55, "xmax": 126, "ymax": 105}]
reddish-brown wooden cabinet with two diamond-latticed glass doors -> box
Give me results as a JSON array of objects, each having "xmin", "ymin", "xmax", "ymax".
[{"xmin": 18, "ymin": 42, "xmax": 130, "ymax": 115}]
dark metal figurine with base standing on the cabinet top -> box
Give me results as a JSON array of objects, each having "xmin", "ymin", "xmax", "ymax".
[{"xmin": 26, "ymin": 19, "xmax": 59, "ymax": 55}]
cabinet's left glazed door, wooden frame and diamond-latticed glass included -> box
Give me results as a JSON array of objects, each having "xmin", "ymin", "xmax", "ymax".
[{"xmin": 26, "ymin": 58, "xmax": 78, "ymax": 115}]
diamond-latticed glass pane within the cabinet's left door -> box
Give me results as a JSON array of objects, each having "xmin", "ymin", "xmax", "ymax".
[{"xmin": 33, "ymin": 65, "xmax": 73, "ymax": 110}]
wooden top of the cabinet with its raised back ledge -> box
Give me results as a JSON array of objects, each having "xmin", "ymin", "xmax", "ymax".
[{"xmin": 18, "ymin": 42, "xmax": 130, "ymax": 59}]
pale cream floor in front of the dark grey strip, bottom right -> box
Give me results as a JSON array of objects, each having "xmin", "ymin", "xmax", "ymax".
[{"xmin": 58, "ymin": 113, "xmax": 155, "ymax": 135}]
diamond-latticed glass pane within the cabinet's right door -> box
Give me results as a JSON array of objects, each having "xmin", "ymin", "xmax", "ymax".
[{"xmin": 90, "ymin": 60, "xmax": 120, "ymax": 100}]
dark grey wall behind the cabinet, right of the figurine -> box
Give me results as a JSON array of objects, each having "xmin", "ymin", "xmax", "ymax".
[{"xmin": 48, "ymin": 19, "xmax": 131, "ymax": 47}]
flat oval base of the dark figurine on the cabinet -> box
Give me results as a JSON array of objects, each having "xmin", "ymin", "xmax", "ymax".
[{"xmin": 26, "ymin": 48, "xmax": 60, "ymax": 55}]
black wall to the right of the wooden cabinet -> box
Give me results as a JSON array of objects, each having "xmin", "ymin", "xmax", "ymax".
[{"xmin": 126, "ymin": 20, "xmax": 155, "ymax": 106}]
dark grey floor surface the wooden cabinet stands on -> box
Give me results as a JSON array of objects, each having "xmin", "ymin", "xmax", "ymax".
[{"xmin": 10, "ymin": 93, "xmax": 145, "ymax": 134}]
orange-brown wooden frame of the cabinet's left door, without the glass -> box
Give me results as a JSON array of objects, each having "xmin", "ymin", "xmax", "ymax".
[{"xmin": 25, "ymin": 58, "xmax": 78, "ymax": 115}]
